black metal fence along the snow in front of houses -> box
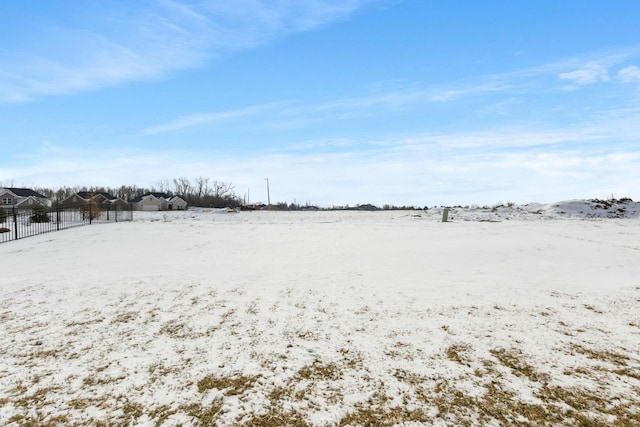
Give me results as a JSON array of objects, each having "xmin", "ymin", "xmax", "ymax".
[{"xmin": 0, "ymin": 206, "xmax": 133, "ymax": 243}]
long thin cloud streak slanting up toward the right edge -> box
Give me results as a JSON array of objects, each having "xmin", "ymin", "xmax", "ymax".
[{"xmin": 138, "ymin": 49, "xmax": 640, "ymax": 135}]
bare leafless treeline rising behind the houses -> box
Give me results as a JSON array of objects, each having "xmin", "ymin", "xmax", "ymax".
[{"xmin": 33, "ymin": 177, "xmax": 243, "ymax": 207}]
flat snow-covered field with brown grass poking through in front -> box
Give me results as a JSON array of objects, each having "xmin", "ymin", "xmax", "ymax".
[{"xmin": 0, "ymin": 201, "xmax": 640, "ymax": 426}]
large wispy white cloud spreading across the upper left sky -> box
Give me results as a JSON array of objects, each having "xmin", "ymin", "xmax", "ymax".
[{"xmin": 0, "ymin": 0, "xmax": 376, "ymax": 104}]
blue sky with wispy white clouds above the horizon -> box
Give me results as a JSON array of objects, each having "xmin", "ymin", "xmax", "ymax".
[{"xmin": 0, "ymin": 0, "xmax": 640, "ymax": 206}]
